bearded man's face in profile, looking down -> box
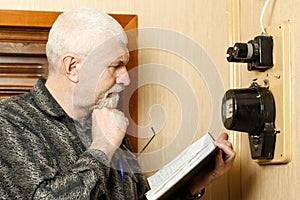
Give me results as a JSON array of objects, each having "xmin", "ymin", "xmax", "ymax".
[{"xmin": 73, "ymin": 40, "xmax": 130, "ymax": 118}]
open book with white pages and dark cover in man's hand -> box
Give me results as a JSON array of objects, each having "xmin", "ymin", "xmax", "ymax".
[{"xmin": 146, "ymin": 133, "xmax": 218, "ymax": 200}]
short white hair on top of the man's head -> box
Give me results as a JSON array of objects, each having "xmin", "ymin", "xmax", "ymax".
[{"xmin": 46, "ymin": 8, "xmax": 128, "ymax": 74}]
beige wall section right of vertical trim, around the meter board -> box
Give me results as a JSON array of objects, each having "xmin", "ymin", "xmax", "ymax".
[{"xmin": 240, "ymin": 0, "xmax": 300, "ymax": 200}]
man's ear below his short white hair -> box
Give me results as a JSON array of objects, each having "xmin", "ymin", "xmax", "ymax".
[{"xmin": 62, "ymin": 54, "xmax": 79, "ymax": 83}]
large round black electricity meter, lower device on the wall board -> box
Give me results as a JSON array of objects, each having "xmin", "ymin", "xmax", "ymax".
[{"xmin": 222, "ymin": 82, "xmax": 276, "ymax": 159}]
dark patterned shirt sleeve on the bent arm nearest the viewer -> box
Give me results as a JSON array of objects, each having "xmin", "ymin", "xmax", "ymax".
[{"xmin": 0, "ymin": 120, "xmax": 109, "ymax": 200}]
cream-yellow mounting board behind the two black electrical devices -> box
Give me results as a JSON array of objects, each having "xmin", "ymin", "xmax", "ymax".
[{"xmin": 249, "ymin": 22, "xmax": 291, "ymax": 164}]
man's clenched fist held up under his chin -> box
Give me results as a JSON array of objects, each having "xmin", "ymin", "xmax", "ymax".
[{"xmin": 89, "ymin": 108, "xmax": 128, "ymax": 160}]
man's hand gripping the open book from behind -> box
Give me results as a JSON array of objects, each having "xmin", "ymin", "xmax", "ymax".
[{"xmin": 188, "ymin": 133, "xmax": 236, "ymax": 195}]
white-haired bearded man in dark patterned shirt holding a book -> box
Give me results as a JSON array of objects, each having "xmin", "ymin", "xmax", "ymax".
[{"xmin": 0, "ymin": 9, "xmax": 235, "ymax": 200}]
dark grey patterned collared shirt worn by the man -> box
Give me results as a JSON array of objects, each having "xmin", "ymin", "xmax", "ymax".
[{"xmin": 0, "ymin": 79, "xmax": 146, "ymax": 200}]
